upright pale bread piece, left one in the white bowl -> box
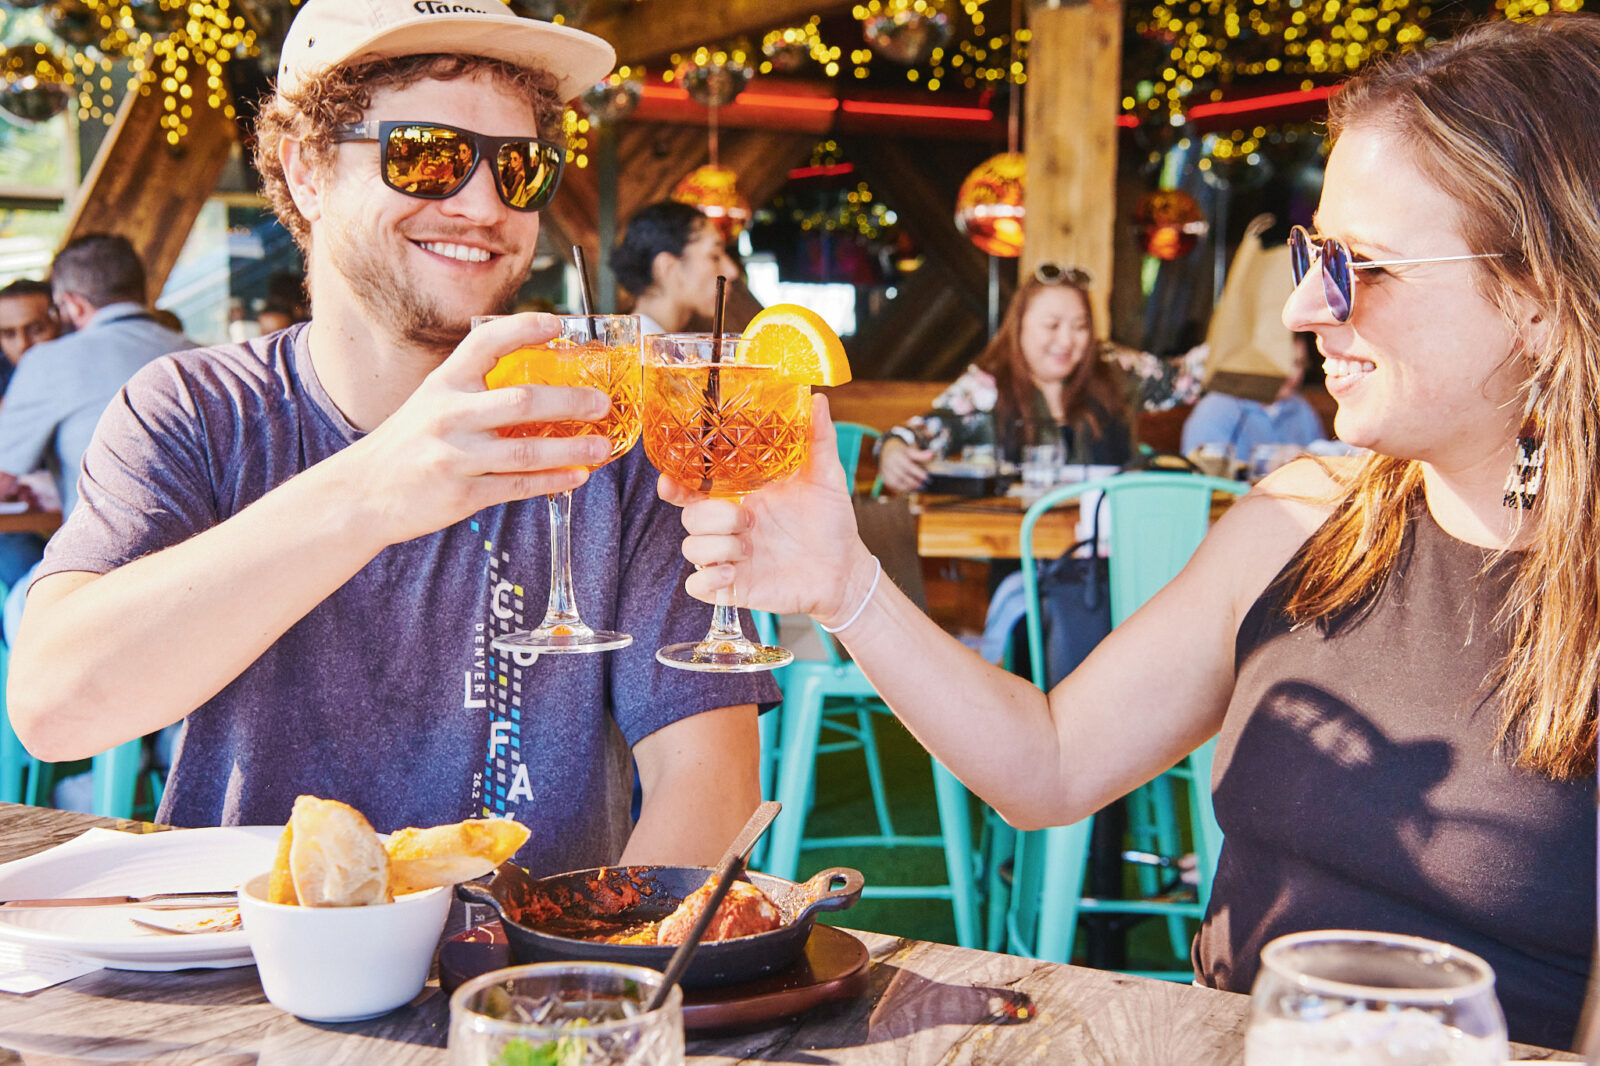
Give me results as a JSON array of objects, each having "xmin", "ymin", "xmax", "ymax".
[{"xmin": 288, "ymin": 795, "xmax": 392, "ymax": 908}]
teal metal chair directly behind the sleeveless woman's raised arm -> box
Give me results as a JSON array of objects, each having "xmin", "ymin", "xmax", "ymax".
[{"xmin": 990, "ymin": 472, "xmax": 1248, "ymax": 980}]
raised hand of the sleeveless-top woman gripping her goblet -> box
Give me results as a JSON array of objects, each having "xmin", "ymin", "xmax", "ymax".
[{"xmin": 658, "ymin": 395, "xmax": 874, "ymax": 624}]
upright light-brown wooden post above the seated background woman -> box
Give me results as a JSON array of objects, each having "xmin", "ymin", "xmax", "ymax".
[{"xmin": 1021, "ymin": 0, "xmax": 1123, "ymax": 330}]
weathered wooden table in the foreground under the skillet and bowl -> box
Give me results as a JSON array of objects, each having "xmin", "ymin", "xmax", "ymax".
[{"xmin": 0, "ymin": 804, "xmax": 1579, "ymax": 1066}]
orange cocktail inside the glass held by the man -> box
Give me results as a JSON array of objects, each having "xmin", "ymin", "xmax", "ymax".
[{"xmin": 483, "ymin": 338, "xmax": 640, "ymax": 469}]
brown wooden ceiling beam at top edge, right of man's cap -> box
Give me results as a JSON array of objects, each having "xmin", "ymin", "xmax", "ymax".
[{"xmin": 582, "ymin": 0, "xmax": 859, "ymax": 62}]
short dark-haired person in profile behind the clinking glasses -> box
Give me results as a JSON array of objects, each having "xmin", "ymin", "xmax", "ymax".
[{"xmin": 611, "ymin": 200, "xmax": 739, "ymax": 335}]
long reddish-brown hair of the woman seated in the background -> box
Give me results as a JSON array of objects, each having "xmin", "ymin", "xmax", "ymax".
[{"xmin": 978, "ymin": 272, "xmax": 1128, "ymax": 435}]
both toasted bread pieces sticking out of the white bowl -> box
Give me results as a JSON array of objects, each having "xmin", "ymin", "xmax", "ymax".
[{"xmin": 267, "ymin": 795, "xmax": 528, "ymax": 908}]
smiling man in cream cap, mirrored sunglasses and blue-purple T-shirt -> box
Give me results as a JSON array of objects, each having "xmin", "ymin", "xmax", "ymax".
[{"xmin": 8, "ymin": 0, "xmax": 778, "ymax": 872}]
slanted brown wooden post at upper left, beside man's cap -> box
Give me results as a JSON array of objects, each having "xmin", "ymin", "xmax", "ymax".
[{"xmin": 66, "ymin": 61, "xmax": 233, "ymax": 301}]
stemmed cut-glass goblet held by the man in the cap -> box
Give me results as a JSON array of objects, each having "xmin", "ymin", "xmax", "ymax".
[{"xmin": 472, "ymin": 315, "xmax": 640, "ymax": 655}]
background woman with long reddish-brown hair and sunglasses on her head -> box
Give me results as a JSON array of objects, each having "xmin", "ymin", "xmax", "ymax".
[{"xmin": 878, "ymin": 270, "xmax": 1133, "ymax": 493}]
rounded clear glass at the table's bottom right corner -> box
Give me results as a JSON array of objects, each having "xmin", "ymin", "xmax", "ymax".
[{"xmin": 1245, "ymin": 930, "xmax": 1510, "ymax": 1066}]
